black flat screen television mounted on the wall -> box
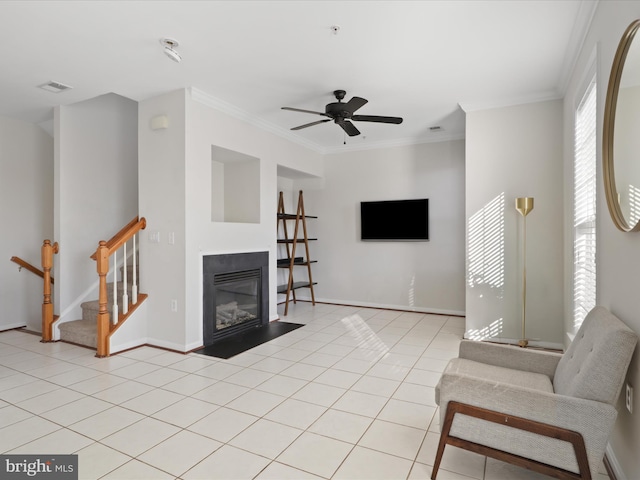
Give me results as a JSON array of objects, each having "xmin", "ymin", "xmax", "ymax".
[{"xmin": 360, "ymin": 198, "xmax": 429, "ymax": 241}]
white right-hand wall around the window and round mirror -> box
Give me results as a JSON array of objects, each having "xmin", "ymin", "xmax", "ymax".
[{"xmin": 564, "ymin": 1, "xmax": 640, "ymax": 480}]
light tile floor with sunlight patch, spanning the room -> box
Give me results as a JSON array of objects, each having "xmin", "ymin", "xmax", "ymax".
[{"xmin": 0, "ymin": 302, "xmax": 607, "ymax": 480}]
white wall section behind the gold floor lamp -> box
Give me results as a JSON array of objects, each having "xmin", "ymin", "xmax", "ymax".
[{"xmin": 466, "ymin": 100, "xmax": 564, "ymax": 346}]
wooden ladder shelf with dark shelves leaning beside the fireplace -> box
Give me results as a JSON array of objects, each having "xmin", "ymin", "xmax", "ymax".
[{"xmin": 277, "ymin": 190, "xmax": 318, "ymax": 316}]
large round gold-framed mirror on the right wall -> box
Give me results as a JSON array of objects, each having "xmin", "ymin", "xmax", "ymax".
[{"xmin": 602, "ymin": 20, "xmax": 640, "ymax": 232}]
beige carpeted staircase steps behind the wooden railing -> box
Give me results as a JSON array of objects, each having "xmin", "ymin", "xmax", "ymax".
[{"xmin": 58, "ymin": 265, "xmax": 139, "ymax": 349}]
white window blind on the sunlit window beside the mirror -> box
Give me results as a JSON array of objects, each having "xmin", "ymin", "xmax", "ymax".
[{"xmin": 573, "ymin": 78, "xmax": 596, "ymax": 328}]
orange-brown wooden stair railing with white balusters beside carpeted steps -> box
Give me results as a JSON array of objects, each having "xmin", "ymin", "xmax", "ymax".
[{"xmin": 91, "ymin": 217, "xmax": 147, "ymax": 357}]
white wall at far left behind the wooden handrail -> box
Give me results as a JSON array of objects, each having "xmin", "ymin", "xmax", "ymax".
[{"xmin": 0, "ymin": 117, "xmax": 56, "ymax": 332}]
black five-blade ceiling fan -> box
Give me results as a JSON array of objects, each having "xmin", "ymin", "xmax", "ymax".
[{"xmin": 282, "ymin": 90, "xmax": 402, "ymax": 137}]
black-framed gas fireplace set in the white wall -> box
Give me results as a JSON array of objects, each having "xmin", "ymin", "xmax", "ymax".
[{"xmin": 202, "ymin": 252, "xmax": 269, "ymax": 346}]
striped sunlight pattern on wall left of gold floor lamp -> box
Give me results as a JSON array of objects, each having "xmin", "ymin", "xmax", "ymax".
[{"xmin": 467, "ymin": 192, "xmax": 505, "ymax": 340}]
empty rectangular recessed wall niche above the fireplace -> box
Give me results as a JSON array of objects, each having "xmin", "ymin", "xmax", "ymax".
[{"xmin": 211, "ymin": 145, "xmax": 260, "ymax": 223}]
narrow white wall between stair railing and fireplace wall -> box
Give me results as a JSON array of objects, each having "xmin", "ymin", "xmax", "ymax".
[{"xmin": 138, "ymin": 90, "xmax": 184, "ymax": 351}]
